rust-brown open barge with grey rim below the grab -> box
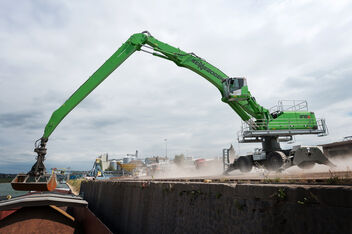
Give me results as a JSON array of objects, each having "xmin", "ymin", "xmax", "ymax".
[{"xmin": 0, "ymin": 190, "xmax": 111, "ymax": 234}]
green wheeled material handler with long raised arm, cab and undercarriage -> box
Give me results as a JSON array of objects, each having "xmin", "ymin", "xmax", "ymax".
[{"xmin": 13, "ymin": 31, "xmax": 331, "ymax": 191}]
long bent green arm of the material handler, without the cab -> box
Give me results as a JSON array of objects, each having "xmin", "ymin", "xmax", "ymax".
[{"xmin": 42, "ymin": 31, "xmax": 266, "ymax": 140}]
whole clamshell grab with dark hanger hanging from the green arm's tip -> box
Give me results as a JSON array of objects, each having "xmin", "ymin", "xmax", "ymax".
[{"xmin": 11, "ymin": 138, "xmax": 57, "ymax": 191}]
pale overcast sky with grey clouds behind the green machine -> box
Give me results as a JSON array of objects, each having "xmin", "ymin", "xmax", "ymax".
[{"xmin": 0, "ymin": 0, "xmax": 352, "ymax": 172}]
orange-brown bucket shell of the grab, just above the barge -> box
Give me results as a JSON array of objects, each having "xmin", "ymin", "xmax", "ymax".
[{"xmin": 11, "ymin": 174, "xmax": 57, "ymax": 191}]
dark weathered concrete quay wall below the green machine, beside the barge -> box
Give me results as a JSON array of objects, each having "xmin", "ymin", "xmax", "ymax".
[{"xmin": 80, "ymin": 181, "xmax": 352, "ymax": 233}]
